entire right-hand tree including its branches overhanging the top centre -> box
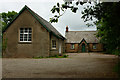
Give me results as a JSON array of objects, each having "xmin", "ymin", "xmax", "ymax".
[{"xmin": 50, "ymin": 0, "xmax": 120, "ymax": 54}]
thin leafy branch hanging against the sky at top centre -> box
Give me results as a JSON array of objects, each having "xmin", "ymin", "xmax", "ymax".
[{"xmin": 50, "ymin": 0, "xmax": 94, "ymax": 23}]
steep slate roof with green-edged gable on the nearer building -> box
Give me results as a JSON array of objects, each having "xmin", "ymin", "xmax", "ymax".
[{"xmin": 2, "ymin": 5, "xmax": 65, "ymax": 39}]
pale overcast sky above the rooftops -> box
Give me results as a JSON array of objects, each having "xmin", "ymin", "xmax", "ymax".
[{"xmin": 0, "ymin": 0, "xmax": 96, "ymax": 36}]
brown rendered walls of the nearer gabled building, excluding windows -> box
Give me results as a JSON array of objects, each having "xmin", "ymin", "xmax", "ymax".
[{"xmin": 3, "ymin": 6, "xmax": 64, "ymax": 58}]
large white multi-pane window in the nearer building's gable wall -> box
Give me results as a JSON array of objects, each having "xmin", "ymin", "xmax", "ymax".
[{"xmin": 20, "ymin": 28, "xmax": 32, "ymax": 42}]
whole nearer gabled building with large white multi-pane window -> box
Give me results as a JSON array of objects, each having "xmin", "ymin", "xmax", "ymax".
[{"xmin": 3, "ymin": 6, "xmax": 65, "ymax": 58}]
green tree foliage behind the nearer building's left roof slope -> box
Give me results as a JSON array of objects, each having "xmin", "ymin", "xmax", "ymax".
[{"xmin": 0, "ymin": 11, "xmax": 17, "ymax": 30}]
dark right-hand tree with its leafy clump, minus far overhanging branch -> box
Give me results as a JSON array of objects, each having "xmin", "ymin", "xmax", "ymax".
[{"xmin": 82, "ymin": 2, "xmax": 120, "ymax": 55}]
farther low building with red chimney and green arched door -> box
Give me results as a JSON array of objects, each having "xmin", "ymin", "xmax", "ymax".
[{"xmin": 65, "ymin": 26, "xmax": 103, "ymax": 53}]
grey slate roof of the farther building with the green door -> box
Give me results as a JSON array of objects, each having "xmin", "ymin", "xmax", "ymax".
[{"xmin": 65, "ymin": 31, "xmax": 99, "ymax": 43}]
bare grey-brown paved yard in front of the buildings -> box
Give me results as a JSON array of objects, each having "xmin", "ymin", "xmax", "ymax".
[{"xmin": 2, "ymin": 53, "xmax": 118, "ymax": 78}]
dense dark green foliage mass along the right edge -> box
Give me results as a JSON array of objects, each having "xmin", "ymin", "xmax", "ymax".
[{"xmin": 96, "ymin": 2, "xmax": 120, "ymax": 55}]
